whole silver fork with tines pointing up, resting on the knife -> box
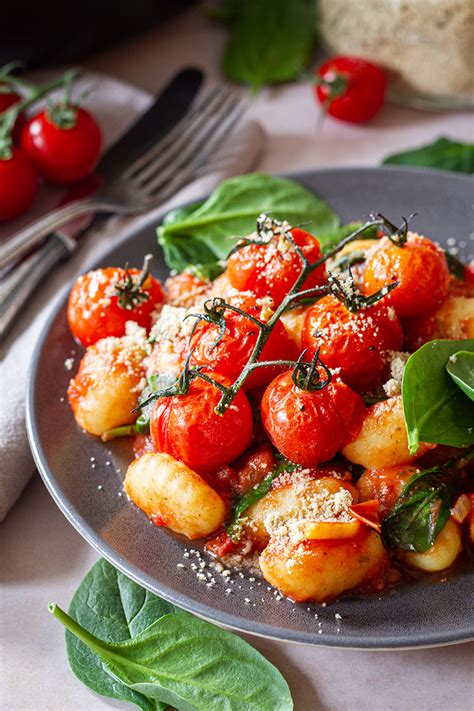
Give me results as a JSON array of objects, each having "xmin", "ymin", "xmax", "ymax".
[{"xmin": 0, "ymin": 87, "xmax": 246, "ymax": 269}]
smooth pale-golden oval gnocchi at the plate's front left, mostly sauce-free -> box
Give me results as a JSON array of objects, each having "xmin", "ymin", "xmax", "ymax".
[{"xmin": 124, "ymin": 453, "xmax": 227, "ymax": 539}]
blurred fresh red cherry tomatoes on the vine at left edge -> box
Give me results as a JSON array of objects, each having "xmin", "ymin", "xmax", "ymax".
[{"xmin": 0, "ymin": 71, "xmax": 102, "ymax": 222}]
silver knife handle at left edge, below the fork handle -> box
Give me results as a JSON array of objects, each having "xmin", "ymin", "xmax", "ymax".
[{"xmin": 0, "ymin": 233, "xmax": 77, "ymax": 340}]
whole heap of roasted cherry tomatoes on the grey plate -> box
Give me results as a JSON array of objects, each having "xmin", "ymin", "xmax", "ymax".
[{"xmin": 68, "ymin": 217, "xmax": 451, "ymax": 484}]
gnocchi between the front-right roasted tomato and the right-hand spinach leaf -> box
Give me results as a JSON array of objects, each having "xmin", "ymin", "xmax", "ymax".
[{"xmin": 341, "ymin": 395, "xmax": 433, "ymax": 469}]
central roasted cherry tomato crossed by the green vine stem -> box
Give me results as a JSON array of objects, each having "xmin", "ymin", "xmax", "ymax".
[{"xmin": 190, "ymin": 294, "xmax": 296, "ymax": 389}]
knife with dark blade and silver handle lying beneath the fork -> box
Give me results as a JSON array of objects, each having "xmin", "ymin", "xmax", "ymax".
[{"xmin": 0, "ymin": 68, "xmax": 203, "ymax": 339}]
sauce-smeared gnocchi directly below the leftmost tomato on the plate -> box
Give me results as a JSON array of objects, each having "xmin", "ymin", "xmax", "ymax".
[{"xmin": 67, "ymin": 329, "xmax": 147, "ymax": 435}]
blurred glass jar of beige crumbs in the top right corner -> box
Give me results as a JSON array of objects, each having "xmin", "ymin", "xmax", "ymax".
[{"xmin": 317, "ymin": 0, "xmax": 474, "ymax": 110}]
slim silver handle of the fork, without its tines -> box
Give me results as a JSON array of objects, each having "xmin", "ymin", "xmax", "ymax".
[{"xmin": 0, "ymin": 197, "xmax": 103, "ymax": 270}]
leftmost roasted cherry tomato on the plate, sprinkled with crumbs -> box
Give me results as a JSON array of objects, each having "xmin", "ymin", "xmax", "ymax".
[{"xmin": 67, "ymin": 267, "xmax": 163, "ymax": 347}]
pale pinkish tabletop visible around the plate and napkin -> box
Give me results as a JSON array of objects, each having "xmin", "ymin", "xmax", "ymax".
[{"xmin": 0, "ymin": 10, "xmax": 474, "ymax": 711}]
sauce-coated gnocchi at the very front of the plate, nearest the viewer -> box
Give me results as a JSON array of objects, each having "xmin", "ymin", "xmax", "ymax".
[{"xmin": 259, "ymin": 526, "xmax": 389, "ymax": 602}]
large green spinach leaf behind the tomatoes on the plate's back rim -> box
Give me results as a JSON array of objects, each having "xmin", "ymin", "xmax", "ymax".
[{"xmin": 158, "ymin": 173, "xmax": 339, "ymax": 271}]
